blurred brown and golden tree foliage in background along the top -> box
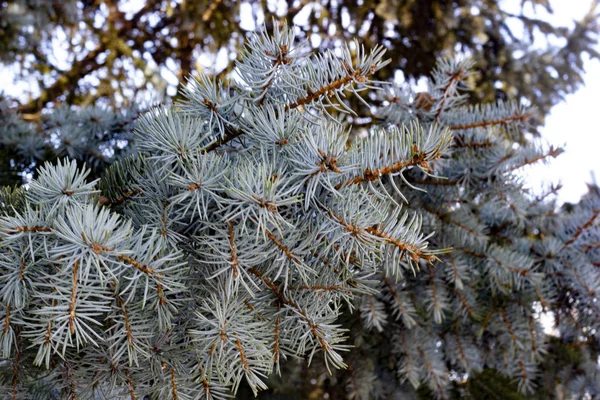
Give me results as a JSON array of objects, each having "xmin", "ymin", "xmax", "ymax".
[{"xmin": 0, "ymin": 0, "xmax": 599, "ymax": 119}]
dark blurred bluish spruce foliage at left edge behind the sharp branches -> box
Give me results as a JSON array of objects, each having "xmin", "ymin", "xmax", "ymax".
[{"xmin": 0, "ymin": 97, "xmax": 139, "ymax": 186}]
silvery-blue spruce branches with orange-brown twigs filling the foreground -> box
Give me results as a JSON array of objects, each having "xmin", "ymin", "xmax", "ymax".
[{"xmin": 0, "ymin": 22, "xmax": 600, "ymax": 399}]
